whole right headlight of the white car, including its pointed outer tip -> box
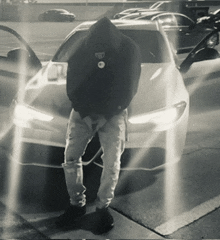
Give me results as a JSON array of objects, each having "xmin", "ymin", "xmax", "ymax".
[{"xmin": 128, "ymin": 101, "xmax": 186, "ymax": 127}]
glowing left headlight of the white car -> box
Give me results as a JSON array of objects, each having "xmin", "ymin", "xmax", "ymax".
[{"xmin": 14, "ymin": 104, "xmax": 53, "ymax": 127}]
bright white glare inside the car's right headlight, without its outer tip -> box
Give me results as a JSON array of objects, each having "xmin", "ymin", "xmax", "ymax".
[{"xmin": 128, "ymin": 108, "xmax": 178, "ymax": 125}]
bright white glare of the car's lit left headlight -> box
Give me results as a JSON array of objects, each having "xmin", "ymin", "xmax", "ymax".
[{"xmin": 14, "ymin": 105, "xmax": 53, "ymax": 122}]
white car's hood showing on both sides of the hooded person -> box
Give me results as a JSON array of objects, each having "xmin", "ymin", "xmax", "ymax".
[{"xmin": 25, "ymin": 62, "xmax": 181, "ymax": 118}]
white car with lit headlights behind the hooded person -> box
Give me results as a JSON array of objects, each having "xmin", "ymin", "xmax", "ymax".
[{"xmin": 5, "ymin": 20, "xmax": 189, "ymax": 171}]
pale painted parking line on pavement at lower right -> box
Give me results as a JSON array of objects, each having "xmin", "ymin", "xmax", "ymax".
[{"xmin": 155, "ymin": 195, "xmax": 220, "ymax": 236}]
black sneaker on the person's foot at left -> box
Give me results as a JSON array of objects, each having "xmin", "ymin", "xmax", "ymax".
[{"xmin": 56, "ymin": 205, "xmax": 86, "ymax": 227}]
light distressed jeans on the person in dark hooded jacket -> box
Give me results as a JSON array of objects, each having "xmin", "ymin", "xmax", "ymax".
[{"xmin": 62, "ymin": 110, "xmax": 127, "ymax": 208}]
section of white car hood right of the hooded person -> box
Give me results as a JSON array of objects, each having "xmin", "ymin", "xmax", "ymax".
[{"xmin": 129, "ymin": 63, "xmax": 181, "ymax": 115}]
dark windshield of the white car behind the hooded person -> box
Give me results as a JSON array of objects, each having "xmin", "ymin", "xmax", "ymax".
[{"xmin": 53, "ymin": 30, "xmax": 170, "ymax": 63}]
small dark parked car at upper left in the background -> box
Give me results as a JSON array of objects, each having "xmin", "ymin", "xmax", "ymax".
[{"xmin": 38, "ymin": 9, "xmax": 76, "ymax": 22}]
